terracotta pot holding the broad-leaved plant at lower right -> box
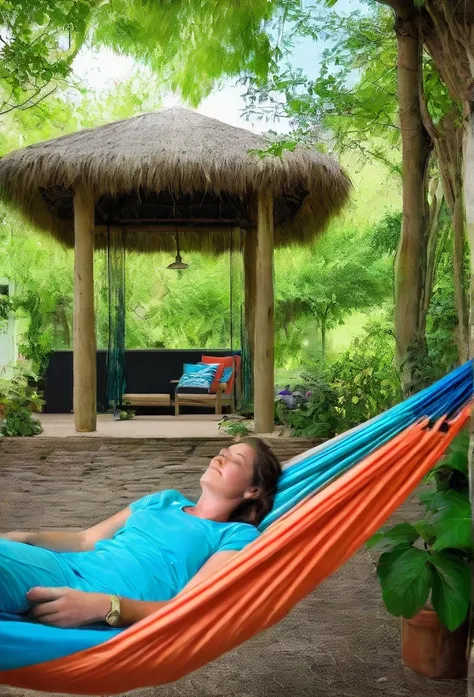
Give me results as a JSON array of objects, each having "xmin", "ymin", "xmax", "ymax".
[{"xmin": 402, "ymin": 609, "xmax": 469, "ymax": 678}]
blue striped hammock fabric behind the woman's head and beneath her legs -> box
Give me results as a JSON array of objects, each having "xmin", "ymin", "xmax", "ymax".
[{"xmin": 0, "ymin": 361, "xmax": 474, "ymax": 671}]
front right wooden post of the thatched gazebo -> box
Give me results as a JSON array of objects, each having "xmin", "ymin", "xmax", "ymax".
[{"xmin": 254, "ymin": 191, "xmax": 275, "ymax": 433}]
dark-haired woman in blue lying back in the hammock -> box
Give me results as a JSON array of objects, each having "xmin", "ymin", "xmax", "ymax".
[{"xmin": 0, "ymin": 438, "xmax": 281, "ymax": 627}]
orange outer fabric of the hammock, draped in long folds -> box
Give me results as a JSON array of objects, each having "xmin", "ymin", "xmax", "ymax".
[{"xmin": 0, "ymin": 406, "xmax": 469, "ymax": 695}]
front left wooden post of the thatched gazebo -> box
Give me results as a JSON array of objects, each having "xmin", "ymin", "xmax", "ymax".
[{"xmin": 73, "ymin": 184, "xmax": 97, "ymax": 432}]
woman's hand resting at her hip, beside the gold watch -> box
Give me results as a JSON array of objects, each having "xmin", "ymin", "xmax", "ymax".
[{"xmin": 26, "ymin": 586, "xmax": 110, "ymax": 628}]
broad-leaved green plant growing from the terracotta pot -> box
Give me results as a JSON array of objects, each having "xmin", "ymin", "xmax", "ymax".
[{"xmin": 368, "ymin": 432, "xmax": 472, "ymax": 631}]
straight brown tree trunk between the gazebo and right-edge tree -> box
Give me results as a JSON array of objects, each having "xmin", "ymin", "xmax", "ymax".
[{"xmin": 395, "ymin": 2, "xmax": 431, "ymax": 395}]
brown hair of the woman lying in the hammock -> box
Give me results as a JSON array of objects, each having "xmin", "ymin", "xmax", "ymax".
[{"xmin": 229, "ymin": 438, "xmax": 281, "ymax": 526}]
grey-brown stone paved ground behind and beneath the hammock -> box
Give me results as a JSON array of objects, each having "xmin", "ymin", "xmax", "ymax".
[{"xmin": 0, "ymin": 437, "xmax": 466, "ymax": 697}]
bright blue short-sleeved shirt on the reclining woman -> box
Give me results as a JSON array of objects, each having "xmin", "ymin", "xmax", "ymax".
[{"xmin": 61, "ymin": 490, "xmax": 260, "ymax": 601}]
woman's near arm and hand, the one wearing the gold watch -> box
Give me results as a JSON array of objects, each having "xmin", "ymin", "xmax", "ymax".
[{"xmin": 27, "ymin": 550, "xmax": 236, "ymax": 627}]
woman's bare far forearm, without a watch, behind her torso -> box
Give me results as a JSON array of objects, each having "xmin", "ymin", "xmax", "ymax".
[{"xmin": 0, "ymin": 506, "xmax": 132, "ymax": 552}]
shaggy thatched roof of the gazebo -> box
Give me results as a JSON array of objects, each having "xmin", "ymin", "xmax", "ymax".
[{"xmin": 0, "ymin": 108, "xmax": 351, "ymax": 252}]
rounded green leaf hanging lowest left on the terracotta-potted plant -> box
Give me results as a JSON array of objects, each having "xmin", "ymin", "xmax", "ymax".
[{"xmin": 377, "ymin": 547, "xmax": 431, "ymax": 617}]
